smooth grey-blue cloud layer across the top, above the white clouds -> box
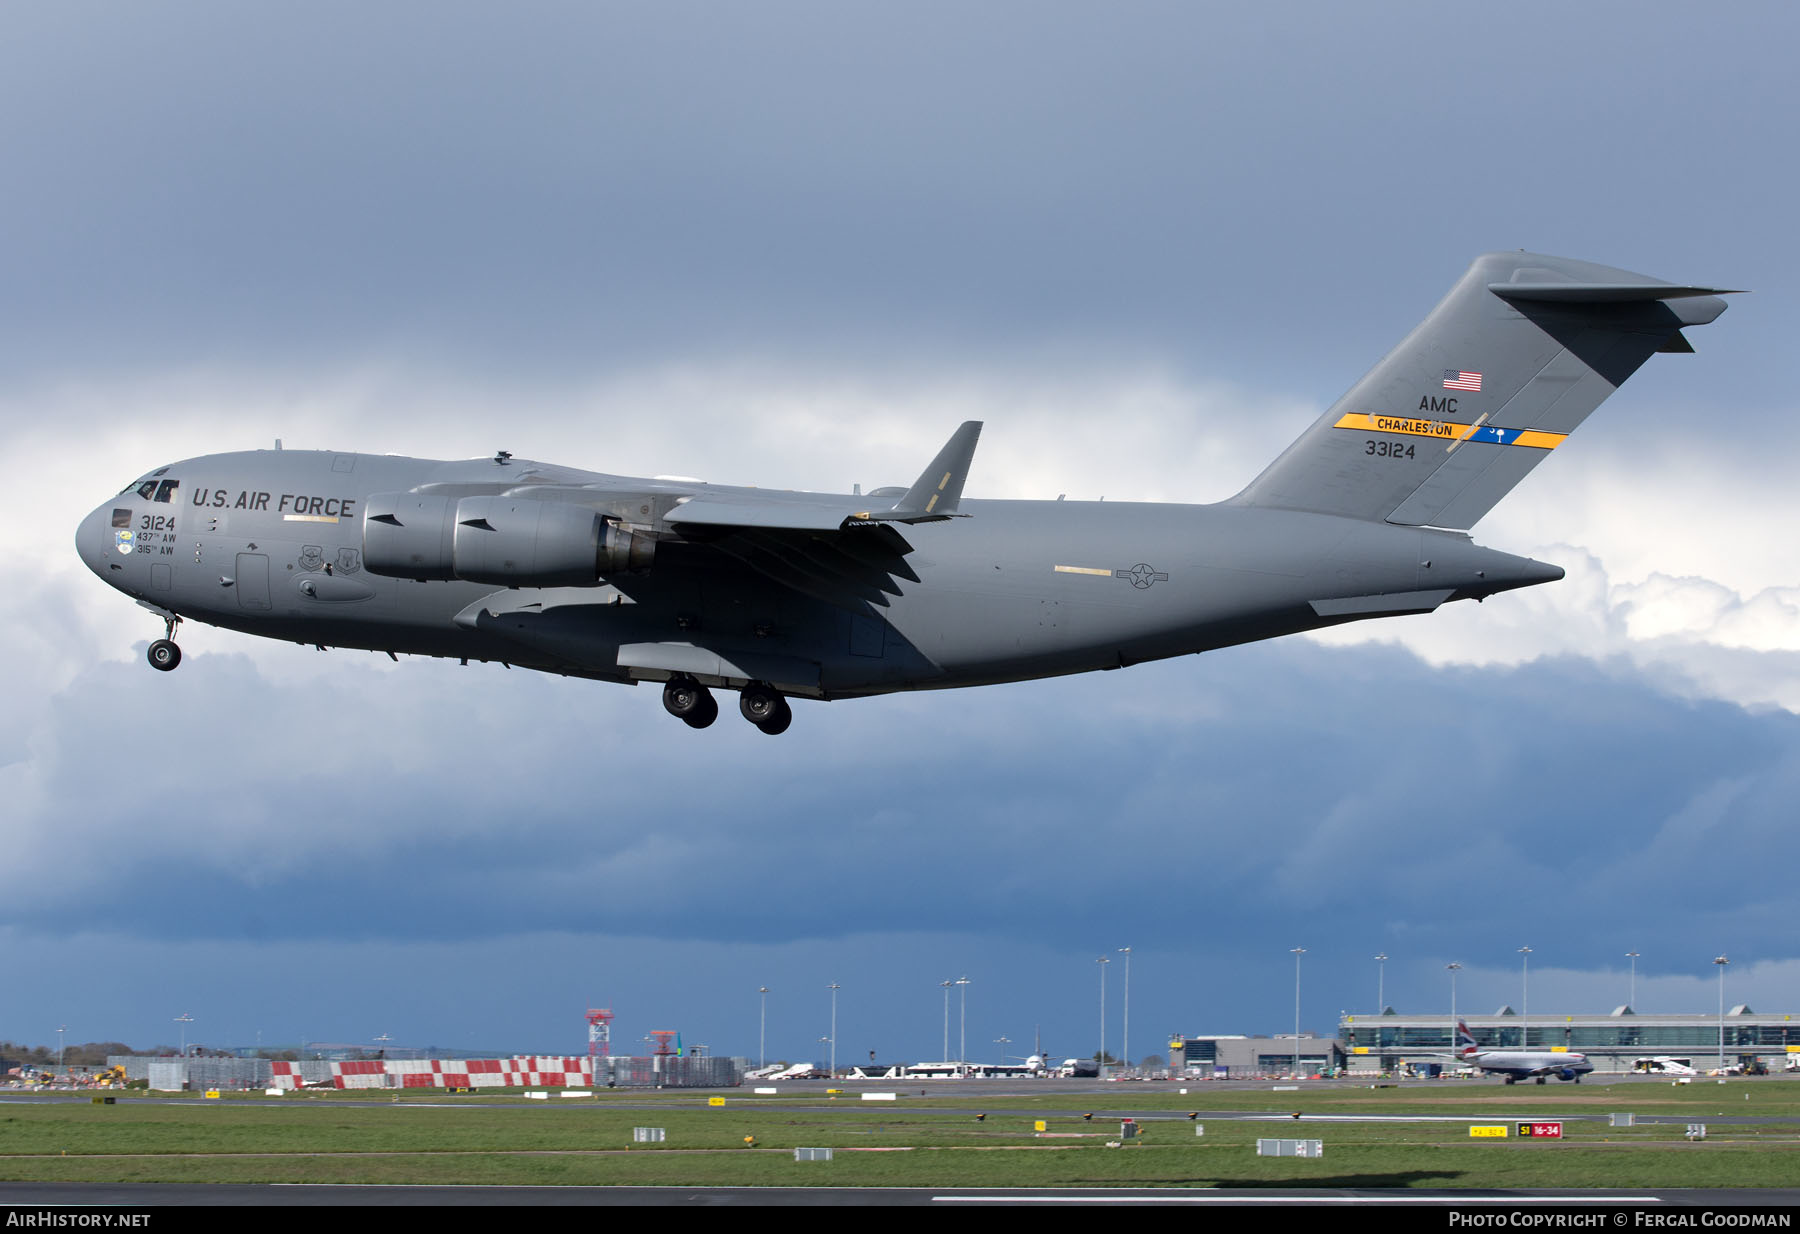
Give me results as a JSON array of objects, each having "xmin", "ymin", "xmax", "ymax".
[{"xmin": 0, "ymin": 4, "xmax": 1769, "ymax": 389}]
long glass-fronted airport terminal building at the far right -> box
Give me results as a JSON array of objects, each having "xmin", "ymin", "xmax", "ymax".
[{"xmin": 1337, "ymin": 1006, "xmax": 1800, "ymax": 1072}]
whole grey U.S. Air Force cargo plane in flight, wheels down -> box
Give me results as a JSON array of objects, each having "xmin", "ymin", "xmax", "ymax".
[{"xmin": 77, "ymin": 252, "xmax": 1724, "ymax": 734}]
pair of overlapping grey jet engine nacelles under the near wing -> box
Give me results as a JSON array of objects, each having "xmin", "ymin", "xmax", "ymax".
[{"xmin": 362, "ymin": 493, "xmax": 655, "ymax": 586}]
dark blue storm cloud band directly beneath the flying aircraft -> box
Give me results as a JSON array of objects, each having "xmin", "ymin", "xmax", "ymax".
[{"xmin": 21, "ymin": 644, "xmax": 1800, "ymax": 962}]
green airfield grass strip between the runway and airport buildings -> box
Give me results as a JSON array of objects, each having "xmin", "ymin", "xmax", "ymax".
[{"xmin": 0, "ymin": 1079, "xmax": 1800, "ymax": 1187}]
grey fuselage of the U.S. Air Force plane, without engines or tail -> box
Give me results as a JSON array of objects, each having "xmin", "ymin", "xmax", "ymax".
[{"xmin": 77, "ymin": 450, "xmax": 1561, "ymax": 698}]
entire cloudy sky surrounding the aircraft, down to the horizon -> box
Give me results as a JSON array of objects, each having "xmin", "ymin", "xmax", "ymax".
[{"xmin": 0, "ymin": 0, "xmax": 1800, "ymax": 1060}]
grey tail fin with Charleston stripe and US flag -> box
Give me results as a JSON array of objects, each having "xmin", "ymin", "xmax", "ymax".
[{"xmin": 1231, "ymin": 252, "xmax": 1728, "ymax": 531}]
